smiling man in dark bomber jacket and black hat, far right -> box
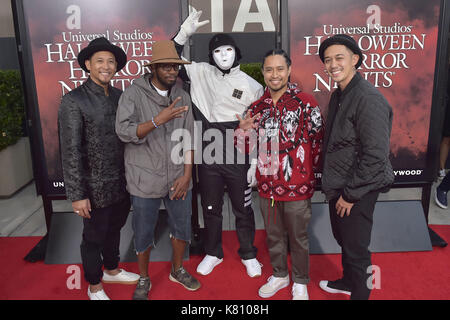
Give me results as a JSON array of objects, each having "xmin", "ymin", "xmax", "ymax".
[{"xmin": 319, "ymin": 34, "xmax": 394, "ymax": 299}]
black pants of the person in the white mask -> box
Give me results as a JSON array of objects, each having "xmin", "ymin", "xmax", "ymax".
[{"xmin": 198, "ymin": 164, "xmax": 257, "ymax": 260}]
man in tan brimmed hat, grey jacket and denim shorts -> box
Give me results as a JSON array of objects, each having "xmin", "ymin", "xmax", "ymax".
[{"xmin": 116, "ymin": 41, "xmax": 200, "ymax": 300}]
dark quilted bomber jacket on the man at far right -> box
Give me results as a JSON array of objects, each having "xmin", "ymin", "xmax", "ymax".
[{"xmin": 322, "ymin": 73, "xmax": 394, "ymax": 203}]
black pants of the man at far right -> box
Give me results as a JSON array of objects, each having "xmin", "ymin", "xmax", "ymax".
[{"xmin": 329, "ymin": 192, "xmax": 379, "ymax": 300}]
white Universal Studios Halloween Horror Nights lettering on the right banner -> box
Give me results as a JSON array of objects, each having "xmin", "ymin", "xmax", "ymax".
[{"xmin": 303, "ymin": 5, "xmax": 427, "ymax": 92}]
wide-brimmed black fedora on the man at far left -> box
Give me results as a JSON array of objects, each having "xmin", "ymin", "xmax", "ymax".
[{"xmin": 77, "ymin": 37, "xmax": 127, "ymax": 72}]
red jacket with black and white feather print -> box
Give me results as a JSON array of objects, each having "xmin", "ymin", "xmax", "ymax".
[{"xmin": 236, "ymin": 83, "xmax": 323, "ymax": 201}]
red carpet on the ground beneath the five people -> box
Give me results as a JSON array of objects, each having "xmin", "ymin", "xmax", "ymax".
[{"xmin": 0, "ymin": 226, "xmax": 450, "ymax": 300}]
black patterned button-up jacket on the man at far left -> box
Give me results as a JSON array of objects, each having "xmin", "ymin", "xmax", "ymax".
[{"xmin": 58, "ymin": 78, "xmax": 128, "ymax": 208}]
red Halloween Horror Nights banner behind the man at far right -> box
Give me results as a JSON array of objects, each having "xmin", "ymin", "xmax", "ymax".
[{"xmin": 288, "ymin": 0, "xmax": 447, "ymax": 182}]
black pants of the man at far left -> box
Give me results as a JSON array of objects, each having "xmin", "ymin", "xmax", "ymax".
[{"xmin": 80, "ymin": 197, "xmax": 131, "ymax": 285}]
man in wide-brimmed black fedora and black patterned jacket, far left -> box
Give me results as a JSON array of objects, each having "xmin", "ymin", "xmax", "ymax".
[{"xmin": 58, "ymin": 38, "xmax": 139, "ymax": 300}]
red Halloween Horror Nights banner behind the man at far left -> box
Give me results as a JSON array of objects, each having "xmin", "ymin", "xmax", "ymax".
[{"xmin": 14, "ymin": 0, "xmax": 181, "ymax": 196}]
